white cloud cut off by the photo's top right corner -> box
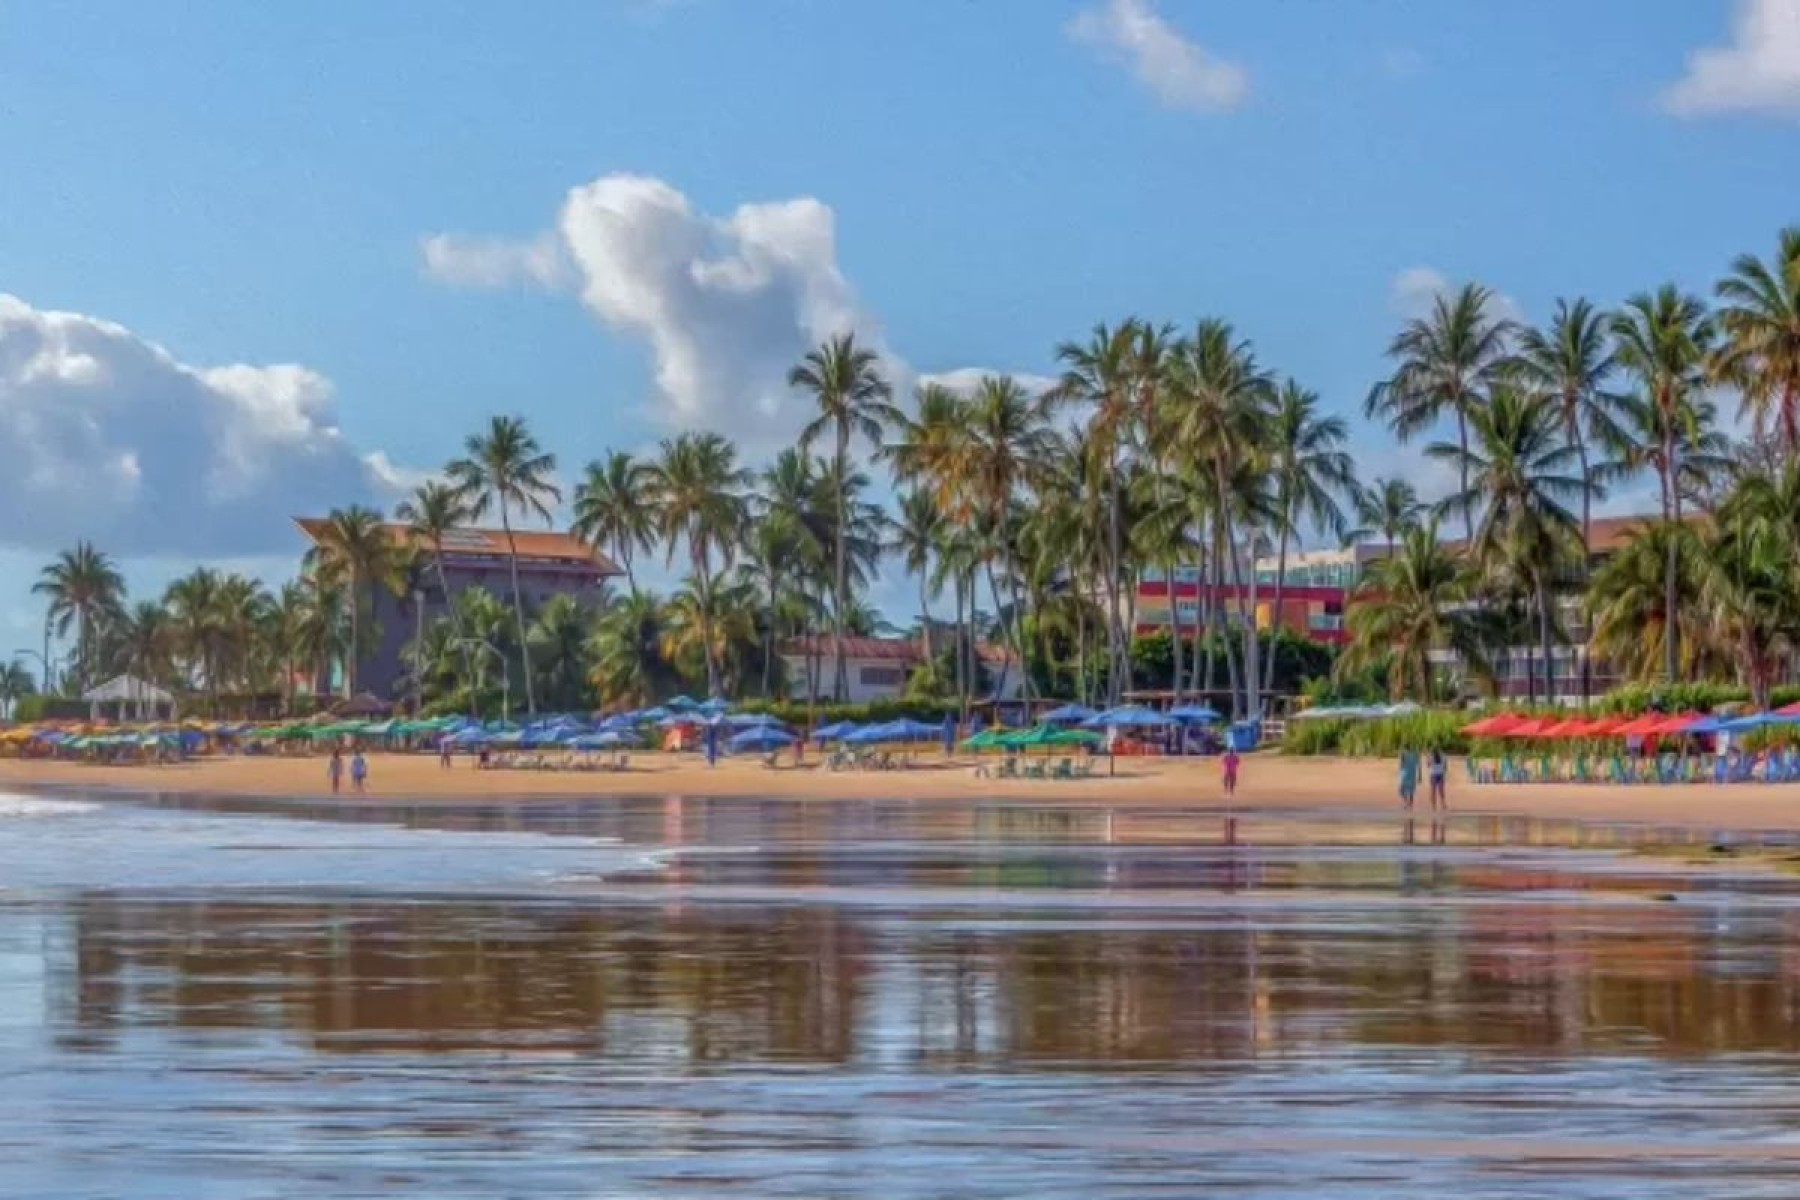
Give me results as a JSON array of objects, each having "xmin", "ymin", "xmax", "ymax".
[{"xmin": 1663, "ymin": 0, "xmax": 1800, "ymax": 117}]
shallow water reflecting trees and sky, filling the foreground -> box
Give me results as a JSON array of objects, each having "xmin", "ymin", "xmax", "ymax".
[{"xmin": 0, "ymin": 797, "xmax": 1800, "ymax": 1200}]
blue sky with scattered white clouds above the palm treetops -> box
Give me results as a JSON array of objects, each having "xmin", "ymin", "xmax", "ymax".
[{"xmin": 0, "ymin": 0, "xmax": 1800, "ymax": 672}]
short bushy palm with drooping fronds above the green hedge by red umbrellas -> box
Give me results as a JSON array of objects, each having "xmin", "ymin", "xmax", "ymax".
[{"xmin": 1334, "ymin": 520, "xmax": 1490, "ymax": 703}]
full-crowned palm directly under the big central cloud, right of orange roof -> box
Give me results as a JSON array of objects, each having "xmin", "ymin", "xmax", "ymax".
[{"xmin": 650, "ymin": 434, "xmax": 751, "ymax": 694}]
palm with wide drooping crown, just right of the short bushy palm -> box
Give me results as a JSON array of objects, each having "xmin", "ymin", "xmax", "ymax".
[{"xmin": 1427, "ymin": 385, "xmax": 1593, "ymax": 702}]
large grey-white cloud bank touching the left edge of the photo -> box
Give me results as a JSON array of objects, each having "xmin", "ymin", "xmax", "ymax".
[{"xmin": 0, "ymin": 293, "xmax": 398, "ymax": 554}]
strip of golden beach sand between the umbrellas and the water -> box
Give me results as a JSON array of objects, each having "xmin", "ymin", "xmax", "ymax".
[{"xmin": 0, "ymin": 752, "xmax": 1800, "ymax": 831}]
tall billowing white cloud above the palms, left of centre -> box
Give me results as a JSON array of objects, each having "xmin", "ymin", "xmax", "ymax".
[{"xmin": 423, "ymin": 175, "xmax": 905, "ymax": 439}]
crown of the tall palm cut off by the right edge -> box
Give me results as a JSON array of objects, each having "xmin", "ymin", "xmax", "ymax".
[{"xmin": 1712, "ymin": 225, "xmax": 1800, "ymax": 459}]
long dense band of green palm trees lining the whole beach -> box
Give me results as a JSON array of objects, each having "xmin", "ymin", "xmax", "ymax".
[{"xmin": 24, "ymin": 228, "xmax": 1800, "ymax": 712}]
